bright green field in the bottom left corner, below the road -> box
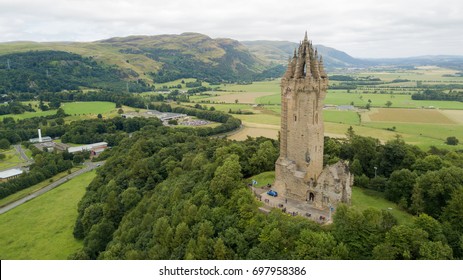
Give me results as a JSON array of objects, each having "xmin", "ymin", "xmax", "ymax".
[{"xmin": 0, "ymin": 171, "xmax": 96, "ymax": 260}]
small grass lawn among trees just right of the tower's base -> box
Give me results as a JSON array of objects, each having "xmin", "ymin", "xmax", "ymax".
[{"xmin": 352, "ymin": 187, "xmax": 413, "ymax": 224}]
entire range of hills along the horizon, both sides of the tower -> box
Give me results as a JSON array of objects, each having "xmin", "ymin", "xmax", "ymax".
[{"xmin": 0, "ymin": 32, "xmax": 463, "ymax": 85}]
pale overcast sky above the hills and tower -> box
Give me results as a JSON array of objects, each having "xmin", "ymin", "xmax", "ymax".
[{"xmin": 0, "ymin": 0, "xmax": 463, "ymax": 57}]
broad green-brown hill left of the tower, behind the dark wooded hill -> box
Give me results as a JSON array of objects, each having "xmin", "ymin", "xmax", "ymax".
[{"xmin": 0, "ymin": 33, "xmax": 284, "ymax": 84}]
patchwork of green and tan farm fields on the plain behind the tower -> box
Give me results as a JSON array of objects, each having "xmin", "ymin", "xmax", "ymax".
[{"xmin": 195, "ymin": 67, "xmax": 463, "ymax": 150}]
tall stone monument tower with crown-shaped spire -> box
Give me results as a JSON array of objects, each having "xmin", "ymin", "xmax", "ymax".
[{"xmin": 275, "ymin": 32, "xmax": 353, "ymax": 208}]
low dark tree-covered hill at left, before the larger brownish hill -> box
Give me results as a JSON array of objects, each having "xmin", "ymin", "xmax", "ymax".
[{"xmin": 0, "ymin": 51, "xmax": 149, "ymax": 94}]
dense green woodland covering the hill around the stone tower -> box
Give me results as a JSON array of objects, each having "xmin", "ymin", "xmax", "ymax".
[{"xmin": 71, "ymin": 123, "xmax": 463, "ymax": 259}]
